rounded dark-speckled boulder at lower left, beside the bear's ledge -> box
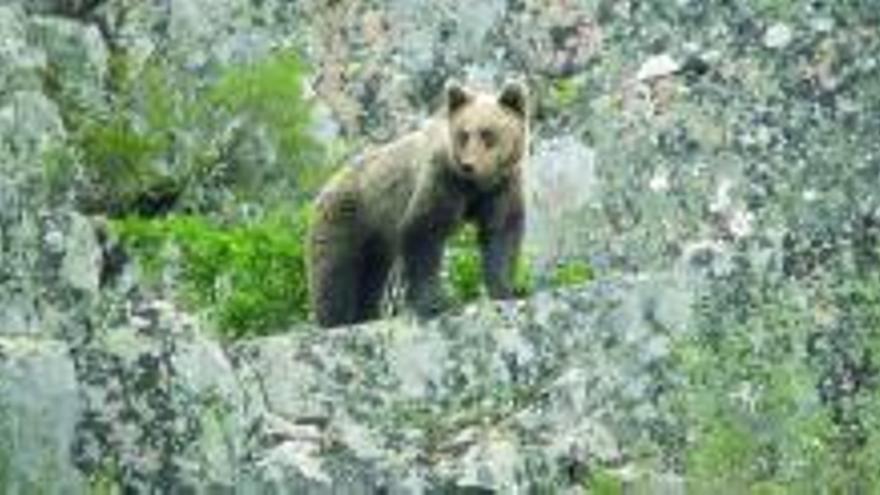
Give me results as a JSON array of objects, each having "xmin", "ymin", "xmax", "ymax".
[{"xmin": 72, "ymin": 301, "xmax": 253, "ymax": 491}]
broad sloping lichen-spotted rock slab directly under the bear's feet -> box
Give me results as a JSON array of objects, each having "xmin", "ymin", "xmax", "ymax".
[{"xmin": 233, "ymin": 281, "xmax": 673, "ymax": 493}]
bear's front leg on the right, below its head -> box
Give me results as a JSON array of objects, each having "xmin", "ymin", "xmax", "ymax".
[{"xmin": 477, "ymin": 194, "xmax": 525, "ymax": 299}]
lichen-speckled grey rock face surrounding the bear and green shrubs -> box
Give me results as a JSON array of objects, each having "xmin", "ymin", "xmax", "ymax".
[{"xmin": 0, "ymin": 0, "xmax": 880, "ymax": 494}]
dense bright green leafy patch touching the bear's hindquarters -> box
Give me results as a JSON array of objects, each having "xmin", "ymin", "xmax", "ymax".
[{"xmin": 113, "ymin": 210, "xmax": 308, "ymax": 338}]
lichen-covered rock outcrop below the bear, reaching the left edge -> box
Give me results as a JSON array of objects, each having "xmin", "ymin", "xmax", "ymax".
[{"xmin": 0, "ymin": 272, "xmax": 678, "ymax": 494}]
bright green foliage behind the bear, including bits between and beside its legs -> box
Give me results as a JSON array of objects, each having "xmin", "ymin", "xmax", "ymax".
[{"xmin": 112, "ymin": 209, "xmax": 592, "ymax": 338}]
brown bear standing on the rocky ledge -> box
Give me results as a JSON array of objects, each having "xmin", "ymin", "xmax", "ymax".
[{"xmin": 307, "ymin": 81, "xmax": 528, "ymax": 327}]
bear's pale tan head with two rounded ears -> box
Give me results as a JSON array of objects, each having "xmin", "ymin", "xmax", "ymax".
[{"xmin": 446, "ymin": 81, "xmax": 528, "ymax": 189}]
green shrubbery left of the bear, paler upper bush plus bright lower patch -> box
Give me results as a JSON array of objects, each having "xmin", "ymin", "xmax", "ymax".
[{"xmin": 50, "ymin": 47, "xmax": 330, "ymax": 337}]
